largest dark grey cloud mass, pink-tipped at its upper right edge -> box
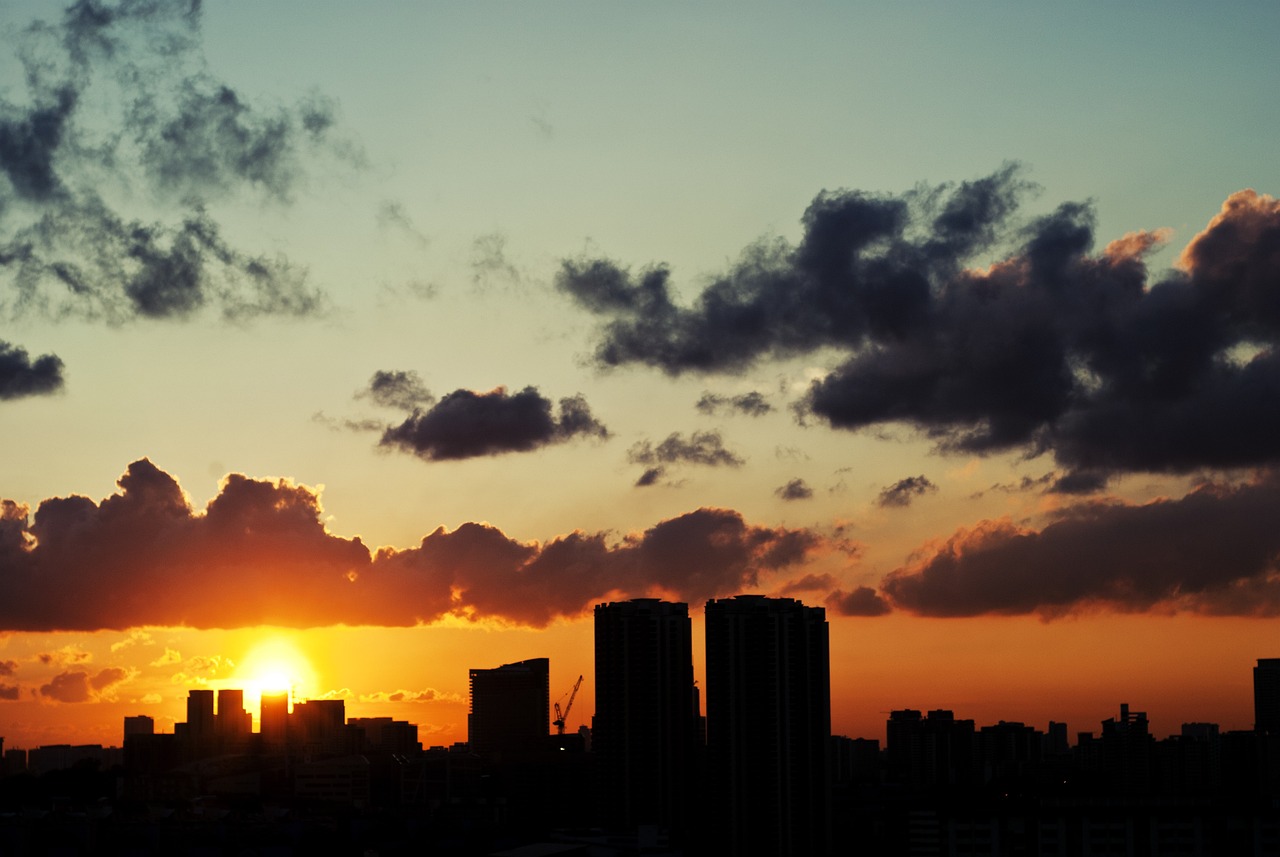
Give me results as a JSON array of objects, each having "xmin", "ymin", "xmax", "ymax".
[{"xmin": 557, "ymin": 166, "xmax": 1280, "ymax": 490}]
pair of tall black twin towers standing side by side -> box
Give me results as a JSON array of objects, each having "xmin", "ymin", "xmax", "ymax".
[{"xmin": 591, "ymin": 595, "xmax": 831, "ymax": 854}]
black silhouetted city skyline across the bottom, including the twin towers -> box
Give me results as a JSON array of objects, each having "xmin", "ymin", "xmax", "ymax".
[{"xmin": 0, "ymin": 619, "xmax": 1280, "ymax": 857}]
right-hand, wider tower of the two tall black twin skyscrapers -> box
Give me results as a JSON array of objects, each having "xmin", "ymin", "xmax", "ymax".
[{"xmin": 707, "ymin": 595, "xmax": 831, "ymax": 857}]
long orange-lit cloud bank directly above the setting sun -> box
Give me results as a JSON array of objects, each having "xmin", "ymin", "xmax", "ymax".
[{"xmin": 0, "ymin": 459, "xmax": 827, "ymax": 631}]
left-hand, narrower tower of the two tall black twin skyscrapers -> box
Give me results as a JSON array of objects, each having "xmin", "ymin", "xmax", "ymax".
[{"xmin": 591, "ymin": 599, "xmax": 699, "ymax": 837}]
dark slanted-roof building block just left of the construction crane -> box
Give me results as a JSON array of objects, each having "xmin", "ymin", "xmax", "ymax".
[{"xmin": 467, "ymin": 657, "xmax": 552, "ymax": 756}]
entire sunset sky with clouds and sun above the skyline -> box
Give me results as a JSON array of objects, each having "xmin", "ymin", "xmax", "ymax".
[{"xmin": 0, "ymin": 0, "xmax": 1280, "ymax": 747}]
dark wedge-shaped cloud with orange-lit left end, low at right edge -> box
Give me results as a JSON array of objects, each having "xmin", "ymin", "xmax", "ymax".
[{"xmin": 881, "ymin": 473, "xmax": 1280, "ymax": 617}]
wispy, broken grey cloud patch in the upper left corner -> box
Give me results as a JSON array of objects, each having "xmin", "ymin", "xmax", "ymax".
[{"xmin": 0, "ymin": 0, "xmax": 355, "ymax": 332}]
